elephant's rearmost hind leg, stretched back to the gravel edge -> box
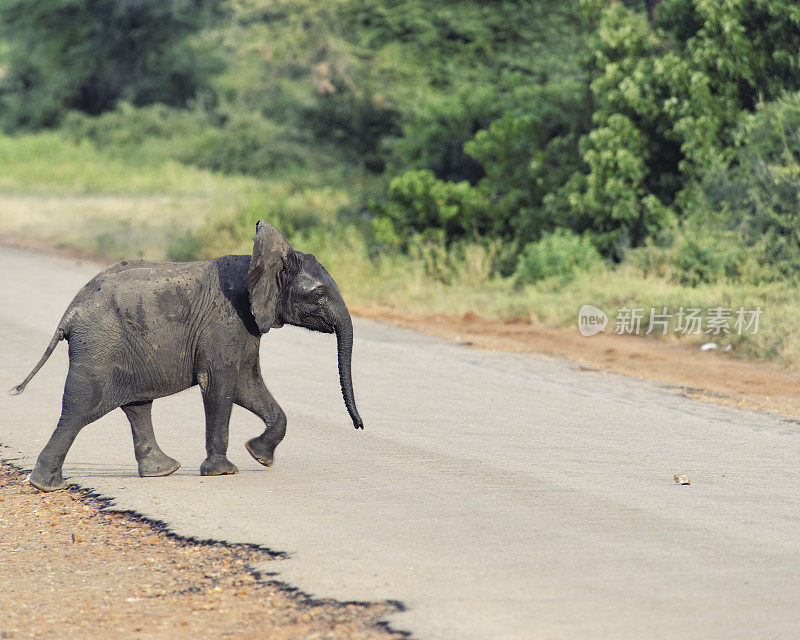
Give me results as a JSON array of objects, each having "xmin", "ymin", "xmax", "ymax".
[{"xmin": 28, "ymin": 365, "xmax": 115, "ymax": 491}]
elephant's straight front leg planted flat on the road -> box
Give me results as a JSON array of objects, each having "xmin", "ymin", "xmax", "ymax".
[{"xmin": 198, "ymin": 372, "xmax": 238, "ymax": 476}]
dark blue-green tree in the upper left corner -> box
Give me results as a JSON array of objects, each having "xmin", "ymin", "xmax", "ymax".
[{"xmin": 0, "ymin": 0, "xmax": 218, "ymax": 129}]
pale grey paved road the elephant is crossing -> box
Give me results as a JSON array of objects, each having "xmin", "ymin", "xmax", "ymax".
[{"xmin": 0, "ymin": 248, "xmax": 800, "ymax": 640}]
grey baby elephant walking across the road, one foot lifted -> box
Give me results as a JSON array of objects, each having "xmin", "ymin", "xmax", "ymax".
[{"xmin": 12, "ymin": 220, "xmax": 364, "ymax": 491}]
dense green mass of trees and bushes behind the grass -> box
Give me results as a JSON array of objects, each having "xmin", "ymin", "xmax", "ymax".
[{"xmin": 0, "ymin": 0, "xmax": 800, "ymax": 284}]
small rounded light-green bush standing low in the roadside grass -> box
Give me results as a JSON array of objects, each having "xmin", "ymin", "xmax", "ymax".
[{"xmin": 517, "ymin": 229, "xmax": 603, "ymax": 283}]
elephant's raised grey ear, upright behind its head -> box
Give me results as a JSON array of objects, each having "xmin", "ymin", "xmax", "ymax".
[{"xmin": 247, "ymin": 220, "xmax": 292, "ymax": 333}]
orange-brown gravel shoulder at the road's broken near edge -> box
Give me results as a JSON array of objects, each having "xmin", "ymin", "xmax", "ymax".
[{"xmin": 0, "ymin": 460, "xmax": 405, "ymax": 640}]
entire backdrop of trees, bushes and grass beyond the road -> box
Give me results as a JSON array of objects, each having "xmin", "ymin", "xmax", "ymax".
[{"xmin": 0, "ymin": 0, "xmax": 800, "ymax": 367}]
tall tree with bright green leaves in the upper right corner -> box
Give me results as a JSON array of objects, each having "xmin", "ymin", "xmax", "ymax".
[{"xmin": 563, "ymin": 0, "xmax": 800, "ymax": 257}]
